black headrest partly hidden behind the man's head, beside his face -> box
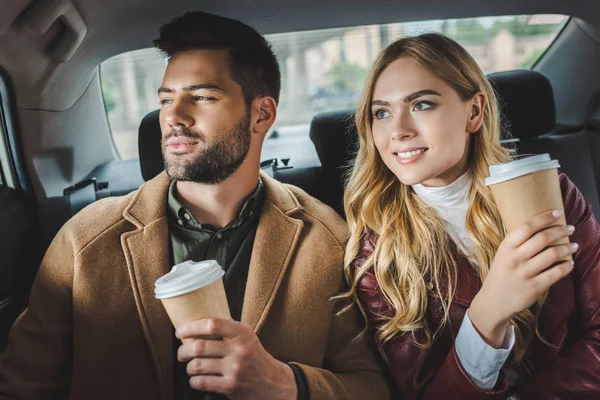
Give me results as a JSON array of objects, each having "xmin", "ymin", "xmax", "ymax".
[{"xmin": 138, "ymin": 110, "xmax": 165, "ymax": 181}]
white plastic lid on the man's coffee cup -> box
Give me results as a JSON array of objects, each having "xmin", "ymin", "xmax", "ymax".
[{"xmin": 154, "ymin": 260, "xmax": 225, "ymax": 299}]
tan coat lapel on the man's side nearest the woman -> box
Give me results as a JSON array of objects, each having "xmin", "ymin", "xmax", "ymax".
[{"xmin": 241, "ymin": 174, "xmax": 304, "ymax": 333}]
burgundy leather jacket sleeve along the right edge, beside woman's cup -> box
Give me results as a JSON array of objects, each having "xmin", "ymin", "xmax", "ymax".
[{"xmin": 517, "ymin": 175, "xmax": 600, "ymax": 399}]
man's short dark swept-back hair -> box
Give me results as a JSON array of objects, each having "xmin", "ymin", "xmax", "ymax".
[{"xmin": 154, "ymin": 11, "xmax": 281, "ymax": 105}]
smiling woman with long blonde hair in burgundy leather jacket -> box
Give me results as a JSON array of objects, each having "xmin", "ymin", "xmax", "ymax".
[{"xmin": 342, "ymin": 34, "xmax": 600, "ymax": 399}]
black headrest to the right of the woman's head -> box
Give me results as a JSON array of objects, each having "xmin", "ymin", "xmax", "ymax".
[{"xmin": 488, "ymin": 70, "xmax": 556, "ymax": 139}]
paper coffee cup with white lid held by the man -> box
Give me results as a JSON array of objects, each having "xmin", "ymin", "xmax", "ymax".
[{"xmin": 154, "ymin": 260, "xmax": 231, "ymax": 334}]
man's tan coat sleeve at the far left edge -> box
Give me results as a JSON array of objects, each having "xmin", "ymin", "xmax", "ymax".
[{"xmin": 0, "ymin": 229, "xmax": 75, "ymax": 400}]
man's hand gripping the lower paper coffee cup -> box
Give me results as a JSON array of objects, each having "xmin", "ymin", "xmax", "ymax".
[{"xmin": 176, "ymin": 318, "xmax": 298, "ymax": 400}]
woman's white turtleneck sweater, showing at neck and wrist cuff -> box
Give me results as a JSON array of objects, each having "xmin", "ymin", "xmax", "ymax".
[{"xmin": 412, "ymin": 172, "xmax": 517, "ymax": 399}]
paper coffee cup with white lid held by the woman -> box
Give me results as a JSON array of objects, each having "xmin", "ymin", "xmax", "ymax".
[{"xmin": 485, "ymin": 154, "xmax": 572, "ymax": 260}]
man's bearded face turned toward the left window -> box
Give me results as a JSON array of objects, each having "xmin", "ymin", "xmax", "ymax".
[{"xmin": 158, "ymin": 50, "xmax": 250, "ymax": 184}]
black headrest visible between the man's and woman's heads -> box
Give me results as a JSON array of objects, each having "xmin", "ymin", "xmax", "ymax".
[{"xmin": 310, "ymin": 110, "xmax": 358, "ymax": 168}]
